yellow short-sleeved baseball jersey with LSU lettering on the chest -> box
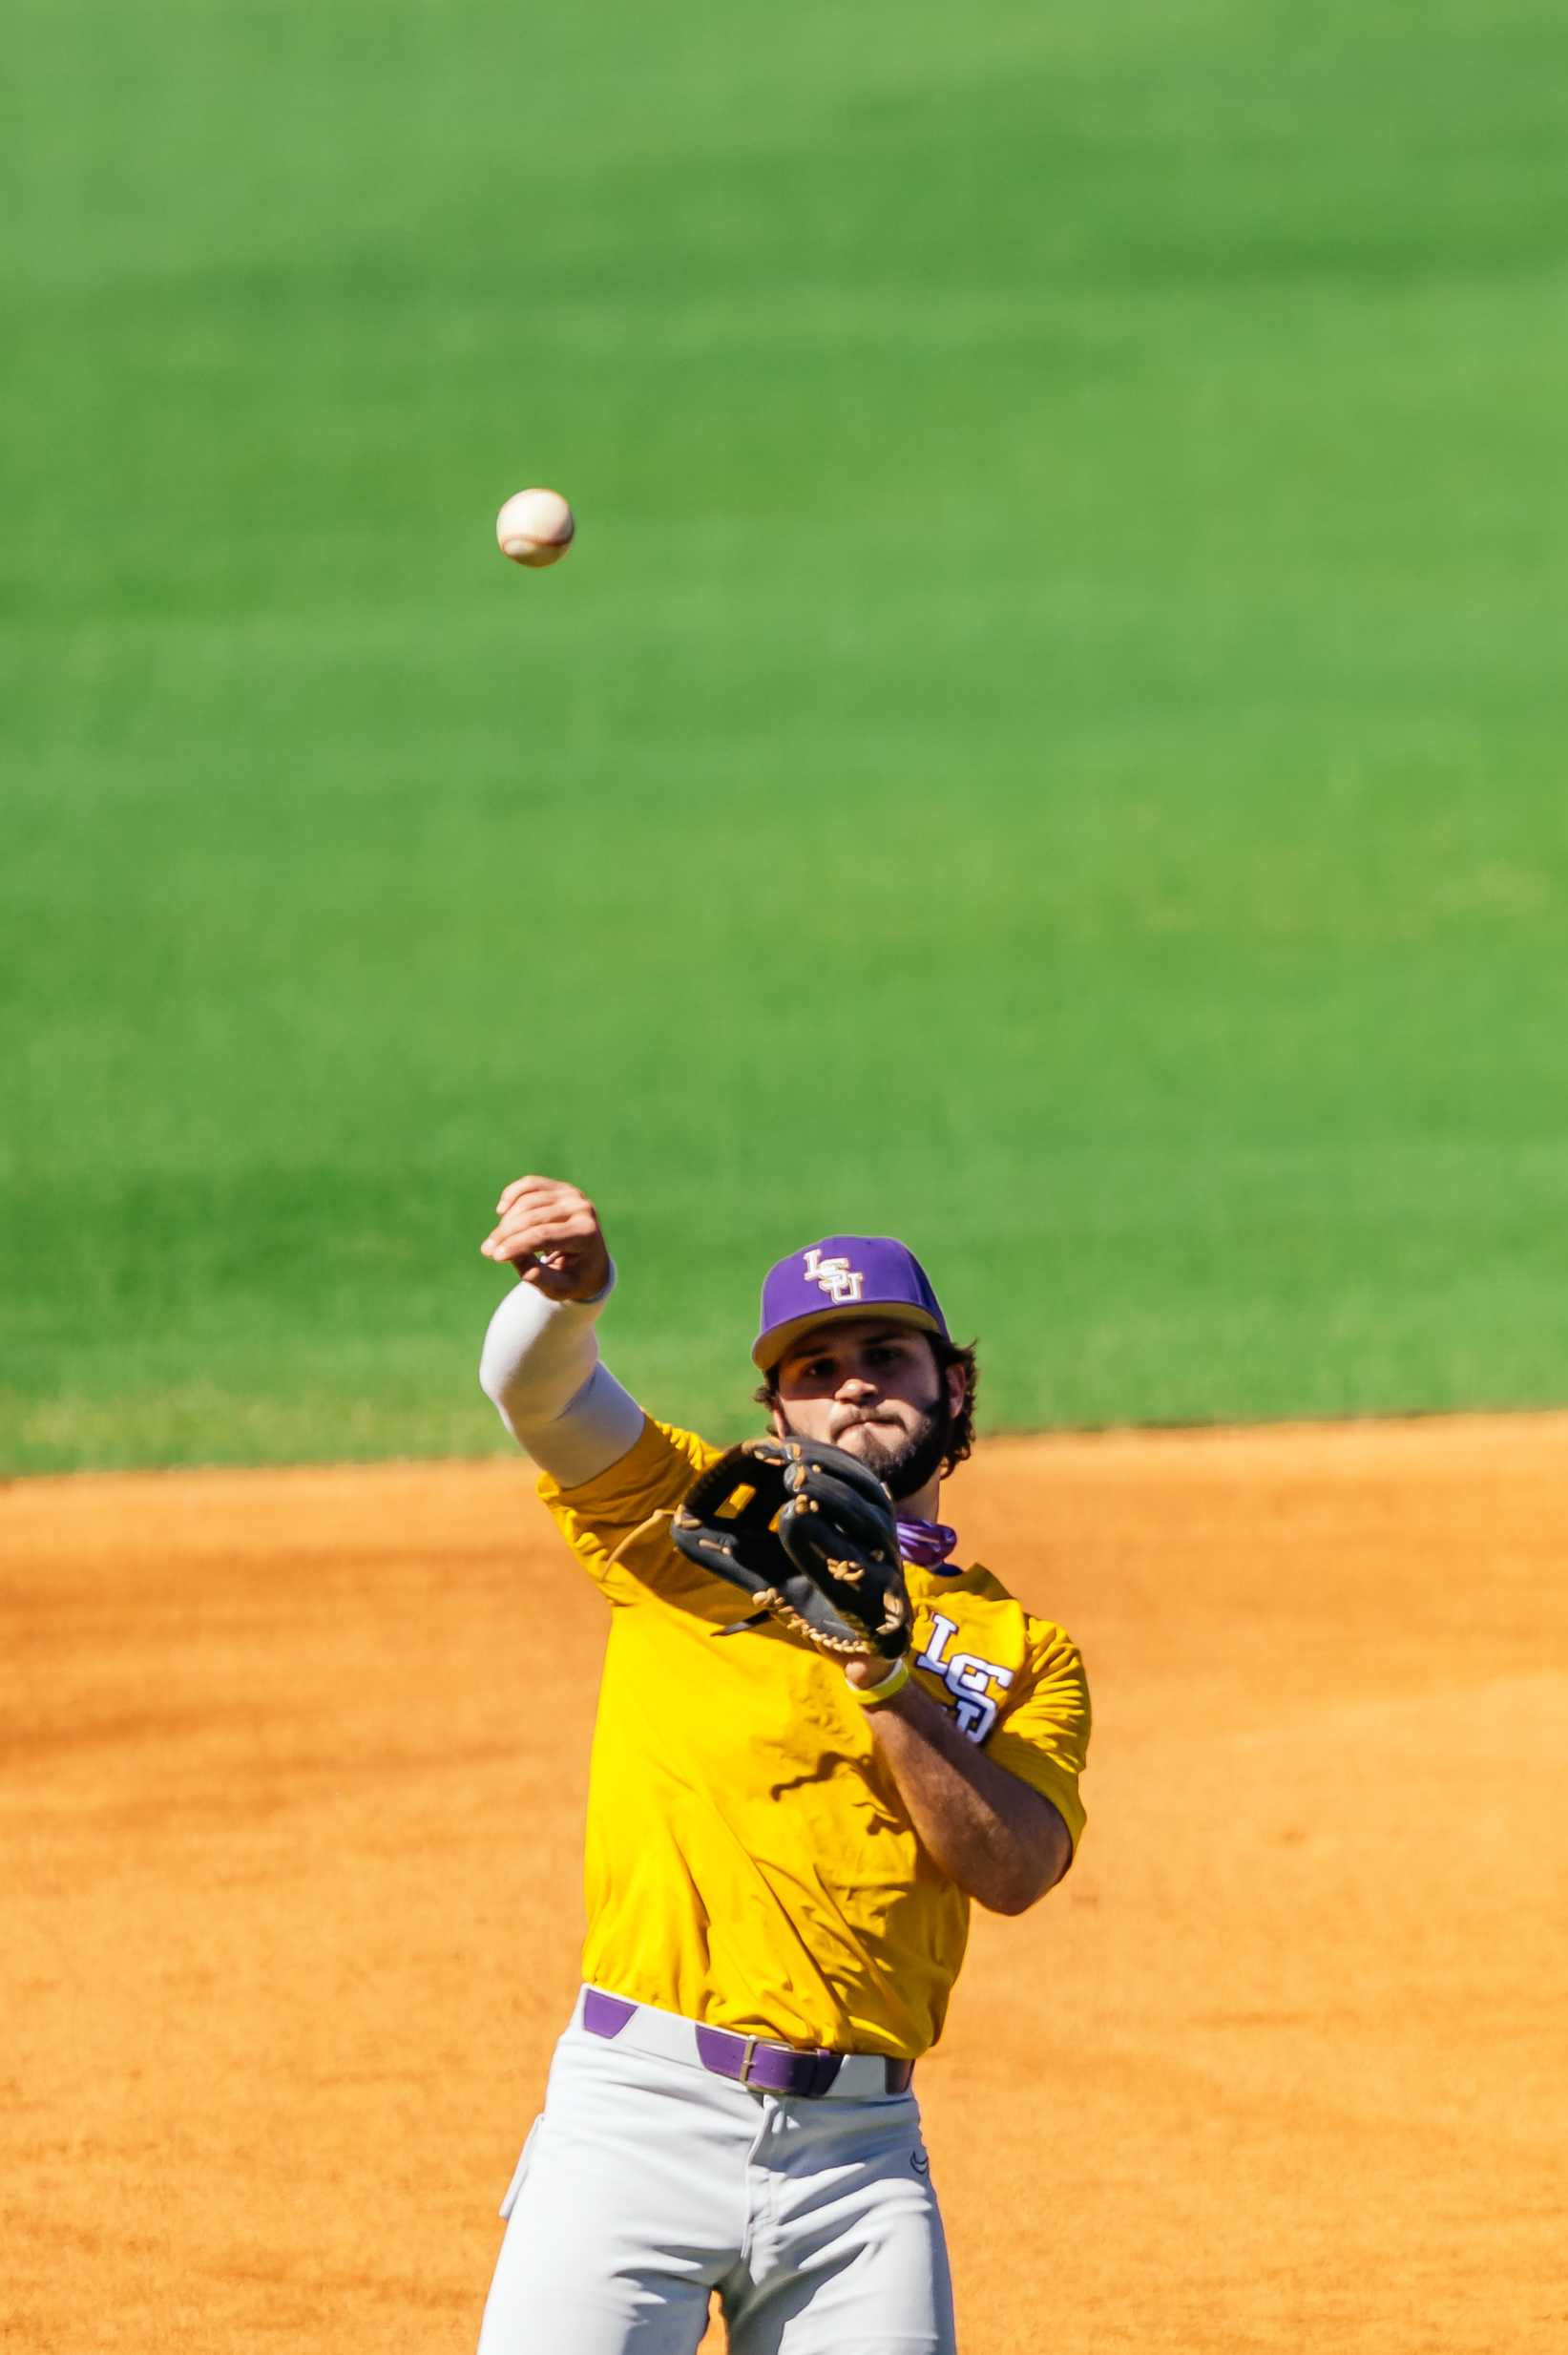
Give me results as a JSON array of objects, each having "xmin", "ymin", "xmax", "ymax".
[{"xmin": 539, "ymin": 1420, "xmax": 1090, "ymax": 2058}]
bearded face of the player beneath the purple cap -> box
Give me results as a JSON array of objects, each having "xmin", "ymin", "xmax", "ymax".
[{"xmin": 775, "ymin": 1316, "xmax": 963, "ymax": 1498}]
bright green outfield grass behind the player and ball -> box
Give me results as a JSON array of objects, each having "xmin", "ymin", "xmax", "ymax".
[{"xmin": 0, "ymin": 0, "xmax": 1568, "ymax": 1469}]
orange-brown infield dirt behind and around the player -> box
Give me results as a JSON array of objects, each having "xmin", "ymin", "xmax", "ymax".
[{"xmin": 0, "ymin": 1416, "xmax": 1568, "ymax": 2355}]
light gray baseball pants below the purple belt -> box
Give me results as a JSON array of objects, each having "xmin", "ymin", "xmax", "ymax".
[{"xmin": 478, "ymin": 1999, "xmax": 956, "ymax": 2355}]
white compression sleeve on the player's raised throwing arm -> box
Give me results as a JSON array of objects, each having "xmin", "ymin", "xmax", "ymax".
[{"xmin": 480, "ymin": 1270, "xmax": 645, "ymax": 1488}]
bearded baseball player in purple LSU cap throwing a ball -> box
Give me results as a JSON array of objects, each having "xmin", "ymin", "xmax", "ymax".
[{"xmin": 480, "ymin": 1178, "xmax": 1090, "ymax": 2355}]
